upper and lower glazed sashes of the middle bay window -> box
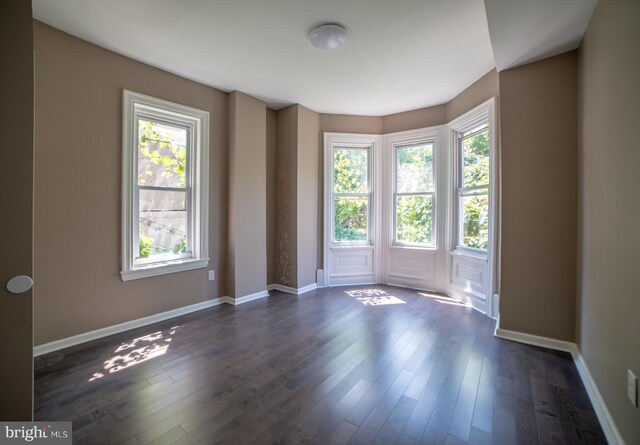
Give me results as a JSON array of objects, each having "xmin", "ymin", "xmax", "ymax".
[{"xmin": 393, "ymin": 143, "xmax": 435, "ymax": 246}]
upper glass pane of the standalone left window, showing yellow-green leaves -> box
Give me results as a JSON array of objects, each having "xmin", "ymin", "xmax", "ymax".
[{"xmin": 138, "ymin": 119, "xmax": 187, "ymax": 187}]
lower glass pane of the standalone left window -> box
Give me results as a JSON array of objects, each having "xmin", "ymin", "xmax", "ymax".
[{"xmin": 138, "ymin": 190, "xmax": 187, "ymax": 258}]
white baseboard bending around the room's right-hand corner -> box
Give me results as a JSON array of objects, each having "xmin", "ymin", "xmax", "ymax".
[{"xmin": 495, "ymin": 321, "xmax": 624, "ymax": 445}]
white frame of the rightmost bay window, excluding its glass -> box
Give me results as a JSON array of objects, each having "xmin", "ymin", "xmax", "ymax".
[{"xmin": 450, "ymin": 111, "xmax": 495, "ymax": 259}]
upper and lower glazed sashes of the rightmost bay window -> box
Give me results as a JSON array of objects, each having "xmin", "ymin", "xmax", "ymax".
[{"xmin": 457, "ymin": 122, "xmax": 490, "ymax": 252}]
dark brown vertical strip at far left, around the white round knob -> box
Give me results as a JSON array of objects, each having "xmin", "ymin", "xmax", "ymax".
[{"xmin": 0, "ymin": 0, "xmax": 33, "ymax": 421}]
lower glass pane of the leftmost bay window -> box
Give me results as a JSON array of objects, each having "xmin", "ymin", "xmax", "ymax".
[{"xmin": 334, "ymin": 196, "xmax": 369, "ymax": 241}]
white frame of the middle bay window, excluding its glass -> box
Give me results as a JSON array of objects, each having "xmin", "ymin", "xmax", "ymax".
[{"xmin": 391, "ymin": 141, "xmax": 438, "ymax": 250}]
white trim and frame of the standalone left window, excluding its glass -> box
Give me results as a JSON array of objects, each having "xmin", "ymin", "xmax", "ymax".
[{"xmin": 120, "ymin": 90, "xmax": 209, "ymax": 281}]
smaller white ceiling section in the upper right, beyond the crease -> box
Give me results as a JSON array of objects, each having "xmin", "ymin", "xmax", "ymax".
[{"xmin": 485, "ymin": 0, "xmax": 598, "ymax": 71}]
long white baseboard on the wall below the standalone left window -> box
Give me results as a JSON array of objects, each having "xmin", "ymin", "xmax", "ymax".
[{"xmin": 33, "ymin": 297, "xmax": 228, "ymax": 357}]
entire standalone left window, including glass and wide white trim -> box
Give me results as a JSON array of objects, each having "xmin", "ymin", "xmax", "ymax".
[{"xmin": 121, "ymin": 90, "xmax": 209, "ymax": 281}]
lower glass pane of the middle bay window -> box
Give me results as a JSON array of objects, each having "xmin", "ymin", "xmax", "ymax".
[{"xmin": 396, "ymin": 195, "xmax": 433, "ymax": 244}]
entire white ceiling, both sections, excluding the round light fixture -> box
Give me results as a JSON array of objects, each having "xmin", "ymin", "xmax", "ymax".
[{"xmin": 33, "ymin": 0, "xmax": 597, "ymax": 115}]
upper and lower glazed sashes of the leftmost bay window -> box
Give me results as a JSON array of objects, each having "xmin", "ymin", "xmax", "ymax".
[{"xmin": 332, "ymin": 147, "xmax": 371, "ymax": 244}]
